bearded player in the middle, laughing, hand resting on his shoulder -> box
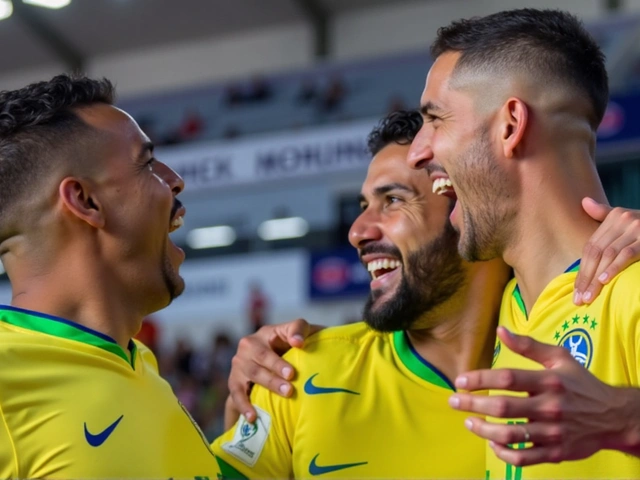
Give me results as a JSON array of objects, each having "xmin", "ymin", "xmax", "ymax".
[{"xmin": 214, "ymin": 112, "xmax": 510, "ymax": 478}]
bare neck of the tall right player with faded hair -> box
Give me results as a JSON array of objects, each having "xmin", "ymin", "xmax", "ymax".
[{"xmin": 503, "ymin": 152, "xmax": 607, "ymax": 312}]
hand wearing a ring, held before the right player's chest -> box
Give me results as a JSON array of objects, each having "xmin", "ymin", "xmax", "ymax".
[{"xmin": 449, "ymin": 327, "xmax": 638, "ymax": 466}]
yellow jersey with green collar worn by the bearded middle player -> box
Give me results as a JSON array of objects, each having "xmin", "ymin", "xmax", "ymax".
[{"xmin": 213, "ymin": 323, "xmax": 485, "ymax": 479}]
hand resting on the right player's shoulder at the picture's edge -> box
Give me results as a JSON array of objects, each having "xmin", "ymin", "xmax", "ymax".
[{"xmin": 573, "ymin": 198, "xmax": 640, "ymax": 305}]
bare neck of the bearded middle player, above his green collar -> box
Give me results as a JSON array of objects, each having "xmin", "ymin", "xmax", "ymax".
[{"xmin": 407, "ymin": 260, "xmax": 509, "ymax": 380}]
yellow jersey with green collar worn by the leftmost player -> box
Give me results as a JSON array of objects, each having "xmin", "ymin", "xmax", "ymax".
[{"xmin": 0, "ymin": 306, "xmax": 219, "ymax": 480}]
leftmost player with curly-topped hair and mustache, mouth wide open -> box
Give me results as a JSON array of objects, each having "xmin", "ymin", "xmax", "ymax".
[{"xmin": 0, "ymin": 75, "xmax": 219, "ymax": 479}]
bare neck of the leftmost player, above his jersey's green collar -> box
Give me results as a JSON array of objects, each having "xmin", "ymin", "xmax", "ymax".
[{"xmin": 5, "ymin": 244, "xmax": 145, "ymax": 352}]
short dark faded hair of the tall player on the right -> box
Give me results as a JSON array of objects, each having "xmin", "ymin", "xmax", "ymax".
[{"xmin": 431, "ymin": 8, "xmax": 609, "ymax": 130}]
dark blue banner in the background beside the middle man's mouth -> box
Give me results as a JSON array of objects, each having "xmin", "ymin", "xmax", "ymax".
[{"xmin": 309, "ymin": 248, "xmax": 371, "ymax": 300}]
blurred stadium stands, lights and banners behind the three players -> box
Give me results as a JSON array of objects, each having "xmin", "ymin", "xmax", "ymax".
[{"xmin": 0, "ymin": 0, "xmax": 640, "ymax": 437}]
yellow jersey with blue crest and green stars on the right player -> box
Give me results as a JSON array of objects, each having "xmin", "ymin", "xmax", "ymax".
[{"xmin": 487, "ymin": 262, "xmax": 640, "ymax": 480}]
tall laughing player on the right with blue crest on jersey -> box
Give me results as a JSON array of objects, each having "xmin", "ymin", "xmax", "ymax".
[{"xmin": 409, "ymin": 9, "xmax": 640, "ymax": 479}]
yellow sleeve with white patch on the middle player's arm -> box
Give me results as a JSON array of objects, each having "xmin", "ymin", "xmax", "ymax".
[{"xmin": 212, "ymin": 349, "xmax": 302, "ymax": 479}]
